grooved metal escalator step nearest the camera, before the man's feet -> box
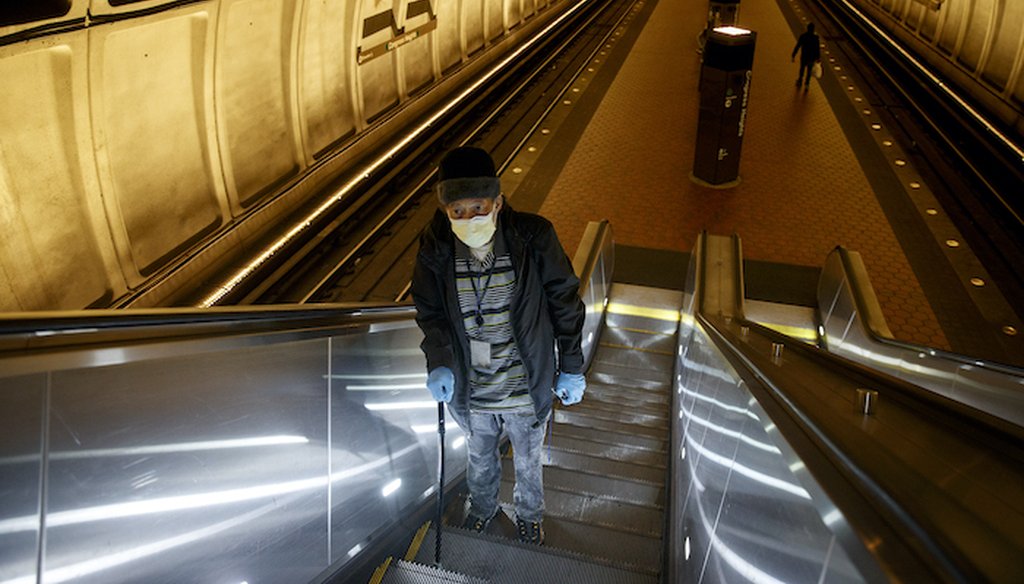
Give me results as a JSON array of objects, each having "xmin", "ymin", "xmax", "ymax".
[{"xmin": 417, "ymin": 522, "xmax": 657, "ymax": 584}]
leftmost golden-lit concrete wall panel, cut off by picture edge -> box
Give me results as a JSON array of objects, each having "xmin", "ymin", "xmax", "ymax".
[{"xmin": 0, "ymin": 42, "xmax": 112, "ymax": 310}]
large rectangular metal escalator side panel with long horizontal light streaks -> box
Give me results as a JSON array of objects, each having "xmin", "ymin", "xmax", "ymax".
[{"xmin": 45, "ymin": 341, "xmax": 327, "ymax": 583}]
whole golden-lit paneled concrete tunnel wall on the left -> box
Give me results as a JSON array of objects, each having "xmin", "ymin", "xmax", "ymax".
[{"xmin": 0, "ymin": 0, "xmax": 565, "ymax": 311}]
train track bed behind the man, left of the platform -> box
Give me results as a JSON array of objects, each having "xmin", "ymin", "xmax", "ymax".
[{"xmin": 192, "ymin": 0, "xmax": 635, "ymax": 304}]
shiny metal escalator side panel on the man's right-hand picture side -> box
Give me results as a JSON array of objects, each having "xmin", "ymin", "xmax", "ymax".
[{"xmin": 671, "ymin": 327, "xmax": 863, "ymax": 582}]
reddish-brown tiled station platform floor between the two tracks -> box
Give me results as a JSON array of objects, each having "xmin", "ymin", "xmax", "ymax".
[{"xmin": 503, "ymin": 0, "xmax": 1024, "ymax": 363}]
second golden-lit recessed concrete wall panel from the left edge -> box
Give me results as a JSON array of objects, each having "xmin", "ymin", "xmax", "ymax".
[{"xmin": 93, "ymin": 13, "xmax": 223, "ymax": 275}]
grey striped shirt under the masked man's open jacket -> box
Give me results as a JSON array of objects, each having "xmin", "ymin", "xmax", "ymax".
[{"xmin": 455, "ymin": 235, "xmax": 534, "ymax": 412}]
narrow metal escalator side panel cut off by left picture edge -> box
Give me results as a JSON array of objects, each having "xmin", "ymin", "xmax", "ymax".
[{"xmin": 0, "ymin": 375, "xmax": 46, "ymax": 582}]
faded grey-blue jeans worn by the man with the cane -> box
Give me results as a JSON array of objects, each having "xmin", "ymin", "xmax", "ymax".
[{"xmin": 463, "ymin": 412, "xmax": 547, "ymax": 522}]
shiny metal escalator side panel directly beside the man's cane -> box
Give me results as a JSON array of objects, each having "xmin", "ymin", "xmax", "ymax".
[{"xmin": 331, "ymin": 322, "xmax": 465, "ymax": 561}]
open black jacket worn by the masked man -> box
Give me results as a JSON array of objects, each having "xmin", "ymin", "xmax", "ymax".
[{"xmin": 412, "ymin": 202, "xmax": 586, "ymax": 420}]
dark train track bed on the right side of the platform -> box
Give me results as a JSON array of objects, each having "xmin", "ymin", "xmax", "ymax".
[{"xmin": 808, "ymin": 0, "xmax": 1024, "ymax": 311}]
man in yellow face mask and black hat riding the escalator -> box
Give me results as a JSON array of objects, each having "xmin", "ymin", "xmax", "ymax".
[{"xmin": 412, "ymin": 147, "xmax": 587, "ymax": 544}]
